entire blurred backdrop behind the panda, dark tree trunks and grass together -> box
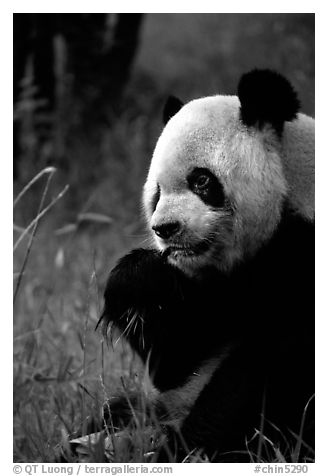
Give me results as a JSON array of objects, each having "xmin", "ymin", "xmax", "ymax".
[{"xmin": 14, "ymin": 14, "xmax": 314, "ymax": 461}]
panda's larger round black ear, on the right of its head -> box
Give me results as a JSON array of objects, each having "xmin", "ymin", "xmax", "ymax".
[{"xmin": 238, "ymin": 69, "xmax": 300, "ymax": 135}]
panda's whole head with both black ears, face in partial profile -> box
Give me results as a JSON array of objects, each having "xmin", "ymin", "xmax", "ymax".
[{"xmin": 143, "ymin": 70, "xmax": 299, "ymax": 274}]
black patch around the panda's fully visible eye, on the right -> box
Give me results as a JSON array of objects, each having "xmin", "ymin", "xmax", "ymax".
[{"xmin": 187, "ymin": 167, "xmax": 225, "ymax": 208}]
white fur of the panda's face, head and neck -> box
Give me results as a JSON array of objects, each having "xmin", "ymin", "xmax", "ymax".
[{"xmin": 144, "ymin": 96, "xmax": 314, "ymax": 273}]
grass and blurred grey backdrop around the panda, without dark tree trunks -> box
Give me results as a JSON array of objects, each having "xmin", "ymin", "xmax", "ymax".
[{"xmin": 14, "ymin": 14, "xmax": 314, "ymax": 462}]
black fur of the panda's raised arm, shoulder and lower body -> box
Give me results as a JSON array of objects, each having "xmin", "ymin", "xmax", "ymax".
[{"xmin": 101, "ymin": 210, "xmax": 314, "ymax": 461}]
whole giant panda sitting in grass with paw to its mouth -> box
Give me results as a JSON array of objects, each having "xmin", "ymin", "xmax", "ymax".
[{"xmin": 100, "ymin": 70, "xmax": 314, "ymax": 462}]
